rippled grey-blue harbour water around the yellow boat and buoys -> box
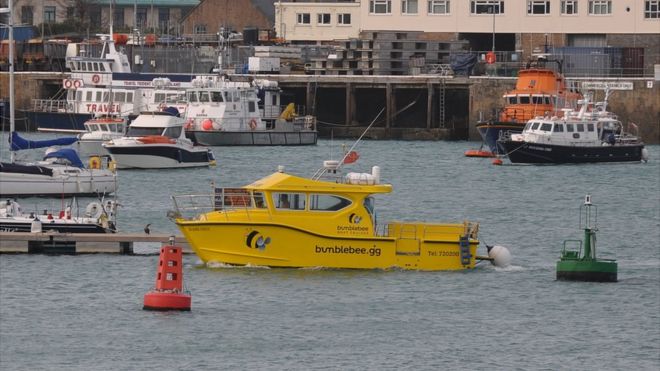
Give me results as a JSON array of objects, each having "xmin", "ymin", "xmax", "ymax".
[{"xmin": 0, "ymin": 138, "xmax": 660, "ymax": 370}]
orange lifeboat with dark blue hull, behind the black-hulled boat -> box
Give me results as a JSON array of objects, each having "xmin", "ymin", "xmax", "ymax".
[{"xmin": 476, "ymin": 56, "xmax": 582, "ymax": 154}]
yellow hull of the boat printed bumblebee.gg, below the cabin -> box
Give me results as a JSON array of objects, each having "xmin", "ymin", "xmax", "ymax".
[{"xmin": 177, "ymin": 220, "xmax": 478, "ymax": 270}]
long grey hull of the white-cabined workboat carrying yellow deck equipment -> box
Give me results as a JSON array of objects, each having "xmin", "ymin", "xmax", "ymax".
[{"xmin": 186, "ymin": 131, "xmax": 318, "ymax": 146}]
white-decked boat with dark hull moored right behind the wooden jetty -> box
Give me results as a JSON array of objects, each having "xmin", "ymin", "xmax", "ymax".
[{"xmin": 0, "ymin": 199, "xmax": 117, "ymax": 233}]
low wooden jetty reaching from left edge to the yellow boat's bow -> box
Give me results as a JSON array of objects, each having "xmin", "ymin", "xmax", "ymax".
[{"xmin": 0, "ymin": 231, "xmax": 192, "ymax": 255}]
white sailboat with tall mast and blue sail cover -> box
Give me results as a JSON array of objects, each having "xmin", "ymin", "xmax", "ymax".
[{"xmin": 0, "ymin": 15, "xmax": 117, "ymax": 197}]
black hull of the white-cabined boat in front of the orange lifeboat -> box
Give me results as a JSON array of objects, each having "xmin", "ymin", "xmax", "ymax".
[{"xmin": 498, "ymin": 140, "xmax": 644, "ymax": 164}]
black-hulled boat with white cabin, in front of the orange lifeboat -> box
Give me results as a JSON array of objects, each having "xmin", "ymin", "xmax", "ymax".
[{"xmin": 498, "ymin": 91, "xmax": 648, "ymax": 164}]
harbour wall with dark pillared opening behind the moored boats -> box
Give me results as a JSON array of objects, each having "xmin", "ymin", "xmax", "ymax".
[{"xmin": 0, "ymin": 72, "xmax": 660, "ymax": 144}]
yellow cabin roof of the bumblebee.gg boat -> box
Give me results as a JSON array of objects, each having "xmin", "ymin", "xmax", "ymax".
[{"xmin": 246, "ymin": 172, "xmax": 392, "ymax": 194}]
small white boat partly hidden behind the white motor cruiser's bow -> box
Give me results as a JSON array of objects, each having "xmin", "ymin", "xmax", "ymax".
[{"xmin": 76, "ymin": 117, "xmax": 127, "ymax": 156}]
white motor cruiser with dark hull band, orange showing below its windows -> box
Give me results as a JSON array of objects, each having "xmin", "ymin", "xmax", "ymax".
[{"xmin": 103, "ymin": 109, "xmax": 215, "ymax": 169}]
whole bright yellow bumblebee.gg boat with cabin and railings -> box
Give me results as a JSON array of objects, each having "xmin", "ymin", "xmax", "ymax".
[{"xmin": 172, "ymin": 161, "xmax": 508, "ymax": 270}]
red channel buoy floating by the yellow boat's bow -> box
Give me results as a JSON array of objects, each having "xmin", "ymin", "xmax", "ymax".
[{"xmin": 142, "ymin": 238, "xmax": 192, "ymax": 311}]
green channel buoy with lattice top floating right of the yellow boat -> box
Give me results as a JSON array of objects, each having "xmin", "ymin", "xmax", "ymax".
[{"xmin": 557, "ymin": 195, "xmax": 618, "ymax": 282}]
